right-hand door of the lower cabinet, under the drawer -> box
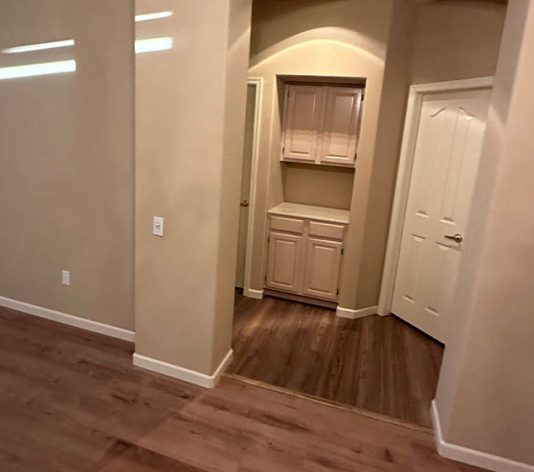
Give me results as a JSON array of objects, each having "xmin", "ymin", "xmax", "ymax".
[{"xmin": 303, "ymin": 238, "xmax": 343, "ymax": 300}]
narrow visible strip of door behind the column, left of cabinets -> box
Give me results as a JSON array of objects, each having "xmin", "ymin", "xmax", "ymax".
[{"xmin": 235, "ymin": 84, "xmax": 256, "ymax": 288}]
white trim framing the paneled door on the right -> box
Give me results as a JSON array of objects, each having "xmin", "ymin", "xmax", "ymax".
[{"xmin": 378, "ymin": 77, "xmax": 493, "ymax": 315}]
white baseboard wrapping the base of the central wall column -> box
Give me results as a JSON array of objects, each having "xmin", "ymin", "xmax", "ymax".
[{"xmin": 133, "ymin": 349, "xmax": 233, "ymax": 388}]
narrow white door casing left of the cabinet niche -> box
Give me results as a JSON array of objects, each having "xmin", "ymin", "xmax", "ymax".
[{"xmin": 243, "ymin": 77, "xmax": 263, "ymax": 298}]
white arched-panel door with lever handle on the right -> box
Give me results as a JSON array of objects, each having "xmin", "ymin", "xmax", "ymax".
[{"xmin": 392, "ymin": 89, "xmax": 491, "ymax": 342}]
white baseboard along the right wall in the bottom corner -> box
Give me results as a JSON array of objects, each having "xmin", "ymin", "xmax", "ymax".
[{"xmin": 431, "ymin": 400, "xmax": 534, "ymax": 472}]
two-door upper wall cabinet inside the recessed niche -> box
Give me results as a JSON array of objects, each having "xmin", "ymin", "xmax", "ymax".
[{"xmin": 281, "ymin": 85, "xmax": 363, "ymax": 167}]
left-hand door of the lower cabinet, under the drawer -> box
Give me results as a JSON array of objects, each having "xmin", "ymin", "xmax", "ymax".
[{"xmin": 266, "ymin": 231, "xmax": 303, "ymax": 293}]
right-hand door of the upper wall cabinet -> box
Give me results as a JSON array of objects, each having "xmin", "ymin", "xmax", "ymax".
[{"xmin": 320, "ymin": 87, "xmax": 362, "ymax": 166}]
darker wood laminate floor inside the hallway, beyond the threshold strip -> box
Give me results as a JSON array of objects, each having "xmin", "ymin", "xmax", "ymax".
[{"xmin": 227, "ymin": 293, "xmax": 443, "ymax": 427}]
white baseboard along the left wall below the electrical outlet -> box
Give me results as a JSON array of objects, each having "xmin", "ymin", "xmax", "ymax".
[{"xmin": 0, "ymin": 296, "xmax": 135, "ymax": 342}]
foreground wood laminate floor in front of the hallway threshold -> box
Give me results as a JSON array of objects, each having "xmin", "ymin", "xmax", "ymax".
[{"xmin": 0, "ymin": 308, "xmax": 488, "ymax": 472}]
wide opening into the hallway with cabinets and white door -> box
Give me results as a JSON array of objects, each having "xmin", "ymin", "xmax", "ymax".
[{"xmin": 227, "ymin": 2, "xmax": 506, "ymax": 427}]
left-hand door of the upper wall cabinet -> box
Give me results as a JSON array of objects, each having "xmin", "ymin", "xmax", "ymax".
[{"xmin": 282, "ymin": 85, "xmax": 324, "ymax": 162}]
